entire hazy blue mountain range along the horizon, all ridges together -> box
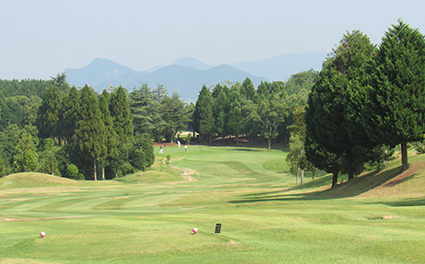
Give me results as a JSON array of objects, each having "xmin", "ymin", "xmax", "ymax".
[{"xmin": 64, "ymin": 53, "xmax": 326, "ymax": 101}]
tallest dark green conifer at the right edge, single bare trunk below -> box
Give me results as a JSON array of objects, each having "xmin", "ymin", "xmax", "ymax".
[{"xmin": 362, "ymin": 20, "xmax": 425, "ymax": 170}]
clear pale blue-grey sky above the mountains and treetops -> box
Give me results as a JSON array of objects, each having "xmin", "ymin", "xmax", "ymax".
[{"xmin": 0, "ymin": 0, "xmax": 425, "ymax": 80}]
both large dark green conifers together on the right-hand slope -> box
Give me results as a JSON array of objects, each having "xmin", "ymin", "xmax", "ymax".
[{"xmin": 300, "ymin": 20, "xmax": 425, "ymax": 186}]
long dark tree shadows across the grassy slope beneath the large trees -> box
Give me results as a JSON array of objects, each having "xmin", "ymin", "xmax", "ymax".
[{"xmin": 229, "ymin": 166, "xmax": 408, "ymax": 206}]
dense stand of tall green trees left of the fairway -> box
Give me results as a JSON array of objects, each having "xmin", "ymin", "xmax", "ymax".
[{"xmin": 0, "ymin": 78, "xmax": 154, "ymax": 180}]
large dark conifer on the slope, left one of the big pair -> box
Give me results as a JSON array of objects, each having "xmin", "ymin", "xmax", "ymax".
[{"xmin": 306, "ymin": 30, "xmax": 375, "ymax": 179}]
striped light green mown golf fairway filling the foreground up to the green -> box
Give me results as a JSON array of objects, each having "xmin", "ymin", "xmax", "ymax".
[{"xmin": 0, "ymin": 147, "xmax": 425, "ymax": 263}]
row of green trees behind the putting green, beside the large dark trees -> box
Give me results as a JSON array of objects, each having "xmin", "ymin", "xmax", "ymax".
[{"xmin": 192, "ymin": 70, "xmax": 318, "ymax": 149}]
